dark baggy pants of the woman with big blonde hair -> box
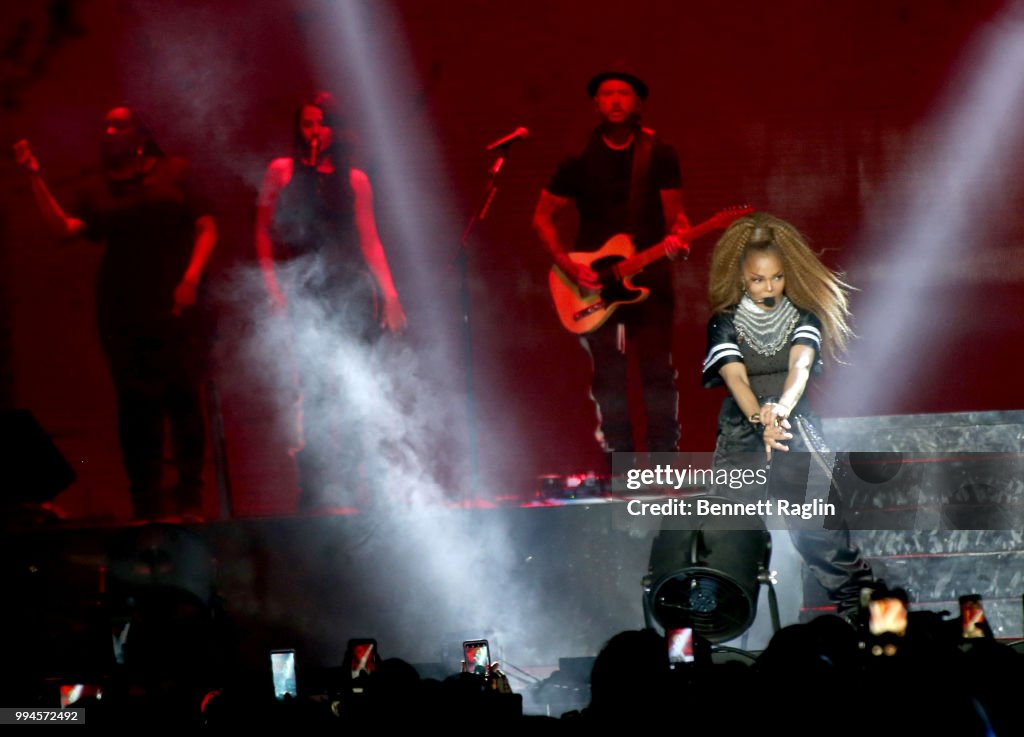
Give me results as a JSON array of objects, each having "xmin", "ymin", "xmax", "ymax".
[{"xmin": 714, "ymin": 397, "xmax": 873, "ymax": 614}]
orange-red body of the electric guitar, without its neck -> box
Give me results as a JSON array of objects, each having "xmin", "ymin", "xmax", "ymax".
[{"xmin": 548, "ymin": 233, "xmax": 650, "ymax": 335}]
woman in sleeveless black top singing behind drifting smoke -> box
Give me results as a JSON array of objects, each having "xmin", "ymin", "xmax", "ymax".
[{"xmin": 256, "ymin": 92, "xmax": 406, "ymax": 507}]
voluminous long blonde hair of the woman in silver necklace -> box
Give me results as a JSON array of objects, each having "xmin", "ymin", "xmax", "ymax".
[{"xmin": 708, "ymin": 212, "xmax": 853, "ymax": 360}]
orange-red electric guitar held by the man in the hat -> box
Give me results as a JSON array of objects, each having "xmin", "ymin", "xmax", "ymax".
[{"xmin": 548, "ymin": 205, "xmax": 754, "ymax": 335}]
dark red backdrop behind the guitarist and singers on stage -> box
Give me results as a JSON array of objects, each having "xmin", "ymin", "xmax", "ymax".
[{"xmin": 0, "ymin": 0, "xmax": 1024, "ymax": 516}]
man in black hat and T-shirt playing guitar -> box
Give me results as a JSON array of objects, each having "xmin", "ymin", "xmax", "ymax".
[{"xmin": 534, "ymin": 66, "xmax": 689, "ymax": 462}]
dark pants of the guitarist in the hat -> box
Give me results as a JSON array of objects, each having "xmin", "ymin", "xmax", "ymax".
[{"xmin": 581, "ymin": 302, "xmax": 679, "ymax": 452}]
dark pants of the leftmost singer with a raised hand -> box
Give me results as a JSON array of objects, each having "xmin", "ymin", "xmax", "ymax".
[{"xmin": 100, "ymin": 316, "xmax": 206, "ymax": 519}]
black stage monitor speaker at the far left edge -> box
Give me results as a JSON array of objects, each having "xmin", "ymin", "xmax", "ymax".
[{"xmin": 0, "ymin": 409, "xmax": 76, "ymax": 505}]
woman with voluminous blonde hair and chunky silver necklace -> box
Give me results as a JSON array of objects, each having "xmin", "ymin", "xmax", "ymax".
[{"xmin": 703, "ymin": 213, "xmax": 872, "ymax": 617}]
